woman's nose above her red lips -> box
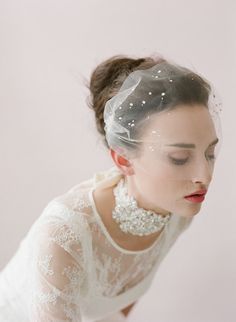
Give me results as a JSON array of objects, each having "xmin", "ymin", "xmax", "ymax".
[{"xmin": 192, "ymin": 159, "xmax": 213, "ymax": 186}]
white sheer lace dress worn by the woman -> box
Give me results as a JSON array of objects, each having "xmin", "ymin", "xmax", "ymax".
[{"xmin": 0, "ymin": 167, "xmax": 192, "ymax": 322}]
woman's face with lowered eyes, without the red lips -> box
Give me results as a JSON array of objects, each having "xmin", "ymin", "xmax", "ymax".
[{"xmin": 126, "ymin": 105, "xmax": 217, "ymax": 217}]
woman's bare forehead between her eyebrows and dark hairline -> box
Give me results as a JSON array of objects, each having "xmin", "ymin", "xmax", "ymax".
[{"xmin": 142, "ymin": 105, "xmax": 216, "ymax": 143}]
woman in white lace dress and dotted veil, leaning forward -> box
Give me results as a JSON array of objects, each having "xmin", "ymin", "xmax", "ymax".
[{"xmin": 0, "ymin": 56, "xmax": 220, "ymax": 322}]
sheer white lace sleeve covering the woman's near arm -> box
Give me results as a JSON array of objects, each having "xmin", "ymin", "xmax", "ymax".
[{"xmin": 28, "ymin": 203, "xmax": 85, "ymax": 322}]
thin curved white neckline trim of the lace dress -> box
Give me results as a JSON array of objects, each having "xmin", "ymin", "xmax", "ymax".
[{"xmin": 89, "ymin": 185, "xmax": 170, "ymax": 255}]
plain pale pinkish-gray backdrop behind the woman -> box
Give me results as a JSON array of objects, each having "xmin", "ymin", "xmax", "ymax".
[{"xmin": 0, "ymin": 0, "xmax": 236, "ymax": 322}]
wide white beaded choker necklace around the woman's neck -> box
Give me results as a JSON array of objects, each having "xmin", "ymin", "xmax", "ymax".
[{"xmin": 112, "ymin": 179, "xmax": 171, "ymax": 236}]
